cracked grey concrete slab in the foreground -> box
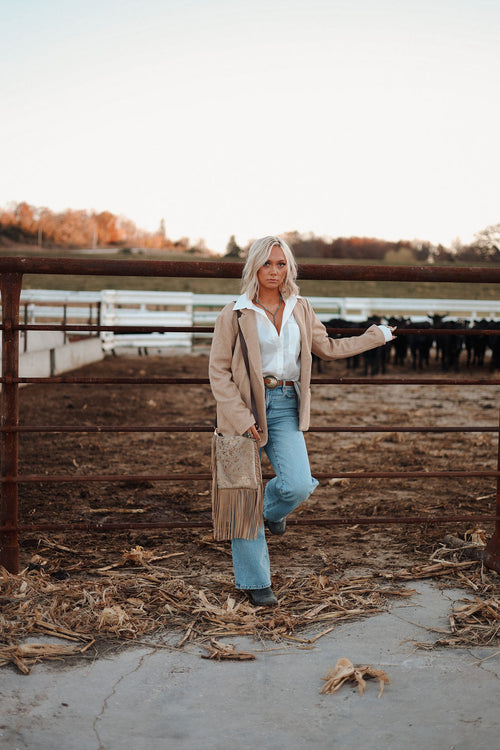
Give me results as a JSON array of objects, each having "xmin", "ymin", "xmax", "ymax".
[{"xmin": 0, "ymin": 582, "xmax": 500, "ymax": 750}]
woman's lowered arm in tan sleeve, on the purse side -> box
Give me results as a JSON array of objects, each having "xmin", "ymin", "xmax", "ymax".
[{"xmin": 208, "ymin": 309, "xmax": 255, "ymax": 435}]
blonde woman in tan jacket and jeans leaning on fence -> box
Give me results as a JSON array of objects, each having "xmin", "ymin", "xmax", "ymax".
[{"xmin": 209, "ymin": 237, "xmax": 395, "ymax": 606}]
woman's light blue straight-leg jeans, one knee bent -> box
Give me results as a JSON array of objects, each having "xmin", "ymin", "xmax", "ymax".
[{"xmin": 232, "ymin": 386, "xmax": 318, "ymax": 589}]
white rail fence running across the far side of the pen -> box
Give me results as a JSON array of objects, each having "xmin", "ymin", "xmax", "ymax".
[{"xmin": 9, "ymin": 289, "xmax": 500, "ymax": 352}]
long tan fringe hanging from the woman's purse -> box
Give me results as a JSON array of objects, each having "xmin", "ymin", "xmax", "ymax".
[{"xmin": 212, "ymin": 434, "xmax": 264, "ymax": 541}]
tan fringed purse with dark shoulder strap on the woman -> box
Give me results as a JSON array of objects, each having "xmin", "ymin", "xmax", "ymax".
[{"xmin": 212, "ymin": 311, "xmax": 264, "ymax": 541}]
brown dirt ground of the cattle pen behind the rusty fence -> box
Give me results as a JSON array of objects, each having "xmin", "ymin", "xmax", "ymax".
[{"xmin": 14, "ymin": 353, "xmax": 500, "ymax": 583}]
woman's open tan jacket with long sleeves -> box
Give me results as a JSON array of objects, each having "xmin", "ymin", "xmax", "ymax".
[{"xmin": 209, "ymin": 297, "xmax": 385, "ymax": 447}]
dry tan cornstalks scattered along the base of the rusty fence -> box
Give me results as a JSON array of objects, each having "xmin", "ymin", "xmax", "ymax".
[{"xmin": 0, "ymin": 536, "xmax": 500, "ymax": 672}]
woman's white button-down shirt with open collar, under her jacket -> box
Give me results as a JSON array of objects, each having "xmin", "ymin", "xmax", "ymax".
[{"xmin": 234, "ymin": 294, "xmax": 300, "ymax": 382}]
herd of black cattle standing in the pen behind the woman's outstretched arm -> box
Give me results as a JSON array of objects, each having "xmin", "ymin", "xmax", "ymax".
[{"xmin": 315, "ymin": 315, "xmax": 500, "ymax": 376}]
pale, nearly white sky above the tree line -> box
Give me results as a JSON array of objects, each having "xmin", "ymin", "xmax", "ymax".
[{"xmin": 0, "ymin": 0, "xmax": 500, "ymax": 252}]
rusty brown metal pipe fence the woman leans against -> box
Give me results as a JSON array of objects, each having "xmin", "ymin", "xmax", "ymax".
[{"xmin": 0, "ymin": 258, "xmax": 500, "ymax": 573}]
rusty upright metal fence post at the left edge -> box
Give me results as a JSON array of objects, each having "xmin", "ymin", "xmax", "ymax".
[{"xmin": 0, "ymin": 273, "xmax": 23, "ymax": 573}]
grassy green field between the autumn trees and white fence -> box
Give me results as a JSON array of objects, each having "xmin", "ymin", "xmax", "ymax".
[{"xmin": 2, "ymin": 248, "xmax": 500, "ymax": 300}]
